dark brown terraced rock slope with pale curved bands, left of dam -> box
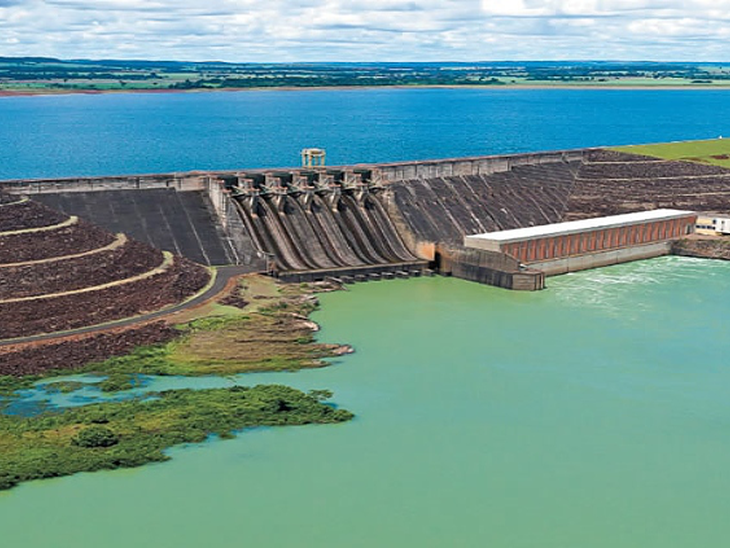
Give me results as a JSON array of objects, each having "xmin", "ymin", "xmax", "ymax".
[{"xmin": 0, "ymin": 193, "xmax": 210, "ymax": 340}]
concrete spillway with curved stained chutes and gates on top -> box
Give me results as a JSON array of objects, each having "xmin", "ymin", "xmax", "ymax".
[{"xmin": 230, "ymin": 174, "xmax": 427, "ymax": 280}]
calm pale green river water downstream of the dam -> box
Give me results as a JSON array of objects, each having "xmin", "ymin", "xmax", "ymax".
[{"xmin": 0, "ymin": 257, "xmax": 730, "ymax": 548}]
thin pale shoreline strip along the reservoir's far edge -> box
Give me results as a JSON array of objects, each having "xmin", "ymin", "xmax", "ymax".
[{"xmin": 0, "ymin": 84, "xmax": 730, "ymax": 99}]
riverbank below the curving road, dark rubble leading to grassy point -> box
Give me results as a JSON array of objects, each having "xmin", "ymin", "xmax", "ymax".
[{"xmin": 0, "ymin": 275, "xmax": 352, "ymax": 390}]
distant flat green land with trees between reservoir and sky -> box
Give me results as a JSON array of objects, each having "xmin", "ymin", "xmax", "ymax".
[{"xmin": 0, "ymin": 57, "xmax": 730, "ymax": 95}]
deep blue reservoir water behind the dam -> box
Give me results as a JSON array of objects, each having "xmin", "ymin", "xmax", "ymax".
[{"xmin": 0, "ymin": 89, "xmax": 730, "ymax": 179}]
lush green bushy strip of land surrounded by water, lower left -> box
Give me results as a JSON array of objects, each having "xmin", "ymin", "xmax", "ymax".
[{"xmin": 0, "ymin": 385, "xmax": 353, "ymax": 489}]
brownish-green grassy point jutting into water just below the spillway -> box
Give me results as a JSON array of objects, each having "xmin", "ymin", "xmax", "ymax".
[{"xmin": 84, "ymin": 277, "xmax": 343, "ymax": 386}]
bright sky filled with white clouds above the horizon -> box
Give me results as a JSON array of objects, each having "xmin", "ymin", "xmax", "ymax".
[{"xmin": 0, "ymin": 0, "xmax": 730, "ymax": 62}]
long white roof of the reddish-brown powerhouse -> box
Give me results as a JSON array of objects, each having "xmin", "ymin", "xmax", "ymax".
[{"xmin": 466, "ymin": 209, "xmax": 695, "ymax": 242}]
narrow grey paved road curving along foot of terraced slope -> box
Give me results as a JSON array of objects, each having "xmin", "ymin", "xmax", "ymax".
[{"xmin": 0, "ymin": 266, "xmax": 251, "ymax": 347}]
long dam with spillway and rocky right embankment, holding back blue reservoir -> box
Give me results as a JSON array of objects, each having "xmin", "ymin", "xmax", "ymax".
[{"xmin": 0, "ymin": 148, "xmax": 730, "ymax": 290}]
